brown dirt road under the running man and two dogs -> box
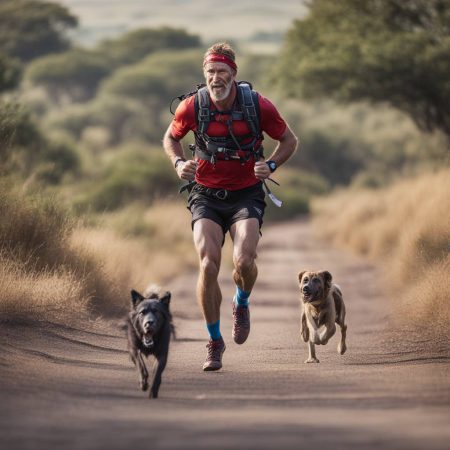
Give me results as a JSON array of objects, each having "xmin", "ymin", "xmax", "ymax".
[{"xmin": 0, "ymin": 221, "xmax": 450, "ymax": 450}]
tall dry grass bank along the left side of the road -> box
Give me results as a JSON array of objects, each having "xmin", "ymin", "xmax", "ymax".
[{"xmin": 0, "ymin": 184, "xmax": 193, "ymax": 322}]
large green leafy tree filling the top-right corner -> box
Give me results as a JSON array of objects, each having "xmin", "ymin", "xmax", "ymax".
[{"xmin": 277, "ymin": 0, "xmax": 450, "ymax": 137}]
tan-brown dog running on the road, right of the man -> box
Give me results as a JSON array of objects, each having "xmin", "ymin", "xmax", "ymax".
[{"xmin": 298, "ymin": 270, "xmax": 347, "ymax": 363}]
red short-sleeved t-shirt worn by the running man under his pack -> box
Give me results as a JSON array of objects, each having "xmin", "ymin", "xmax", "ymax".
[{"xmin": 171, "ymin": 94, "xmax": 287, "ymax": 191}]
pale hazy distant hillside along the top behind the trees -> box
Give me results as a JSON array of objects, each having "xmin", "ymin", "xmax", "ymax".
[{"xmin": 45, "ymin": 0, "xmax": 306, "ymax": 48}]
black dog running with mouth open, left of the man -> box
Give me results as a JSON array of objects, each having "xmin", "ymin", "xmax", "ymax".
[{"xmin": 127, "ymin": 290, "xmax": 174, "ymax": 398}]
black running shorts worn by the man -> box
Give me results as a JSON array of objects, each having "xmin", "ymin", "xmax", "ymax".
[{"xmin": 188, "ymin": 183, "xmax": 266, "ymax": 234}]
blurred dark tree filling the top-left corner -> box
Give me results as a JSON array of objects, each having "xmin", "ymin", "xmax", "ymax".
[{"xmin": 0, "ymin": 0, "xmax": 78, "ymax": 62}]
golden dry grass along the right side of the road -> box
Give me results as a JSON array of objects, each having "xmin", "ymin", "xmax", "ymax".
[{"xmin": 313, "ymin": 169, "xmax": 450, "ymax": 334}]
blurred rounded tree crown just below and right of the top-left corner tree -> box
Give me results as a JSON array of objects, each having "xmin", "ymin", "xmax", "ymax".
[{"xmin": 27, "ymin": 49, "xmax": 111, "ymax": 102}]
